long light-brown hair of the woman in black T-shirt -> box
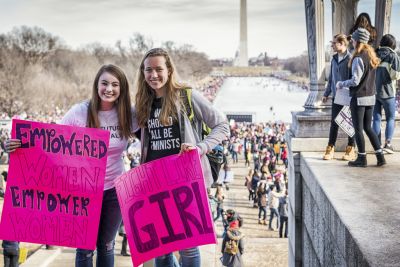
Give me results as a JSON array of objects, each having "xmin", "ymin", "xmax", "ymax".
[{"xmin": 135, "ymin": 48, "xmax": 188, "ymax": 127}]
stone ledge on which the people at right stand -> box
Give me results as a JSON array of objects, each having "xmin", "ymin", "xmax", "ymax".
[{"xmin": 299, "ymin": 152, "xmax": 400, "ymax": 266}]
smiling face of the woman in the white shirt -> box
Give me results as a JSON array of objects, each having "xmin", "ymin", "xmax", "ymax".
[{"xmin": 97, "ymin": 72, "xmax": 120, "ymax": 110}]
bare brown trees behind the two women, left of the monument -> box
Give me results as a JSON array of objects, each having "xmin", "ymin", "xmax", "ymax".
[{"xmin": 0, "ymin": 26, "xmax": 211, "ymax": 116}]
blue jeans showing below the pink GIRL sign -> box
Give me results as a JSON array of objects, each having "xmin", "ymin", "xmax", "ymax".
[{"xmin": 156, "ymin": 247, "xmax": 200, "ymax": 267}]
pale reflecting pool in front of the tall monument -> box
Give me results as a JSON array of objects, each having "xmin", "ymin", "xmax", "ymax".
[{"xmin": 214, "ymin": 77, "xmax": 308, "ymax": 122}]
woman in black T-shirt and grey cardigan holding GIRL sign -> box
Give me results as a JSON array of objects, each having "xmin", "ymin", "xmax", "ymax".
[{"xmin": 135, "ymin": 48, "xmax": 229, "ymax": 267}]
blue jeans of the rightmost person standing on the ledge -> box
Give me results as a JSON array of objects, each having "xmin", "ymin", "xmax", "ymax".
[{"xmin": 372, "ymin": 97, "xmax": 396, "ymax": 146}]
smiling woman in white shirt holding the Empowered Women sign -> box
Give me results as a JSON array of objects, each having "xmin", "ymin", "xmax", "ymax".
[{"xmin": 6, "ymin": 64, "xmax": 138, "ymax": 267}]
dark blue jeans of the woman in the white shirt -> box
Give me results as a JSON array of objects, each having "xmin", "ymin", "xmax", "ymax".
[{"xmin": 75, "ymin": 188, "xmax": 122, "ymax": 267}]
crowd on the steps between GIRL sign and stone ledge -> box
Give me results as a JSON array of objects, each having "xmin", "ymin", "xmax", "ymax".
[{"xmin": 199, "ymin": 123, "xmax": 289, "ymax": 266}]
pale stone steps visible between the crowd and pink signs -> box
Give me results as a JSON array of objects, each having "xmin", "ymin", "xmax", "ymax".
[{"xmin": 0, "ymin": 161, "xmax": 288, "ymax": 267}]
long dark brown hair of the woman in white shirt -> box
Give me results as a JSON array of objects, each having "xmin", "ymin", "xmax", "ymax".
[{"xmin": 87, "ymin": 64, "xmax": 133, "ymax": 139}]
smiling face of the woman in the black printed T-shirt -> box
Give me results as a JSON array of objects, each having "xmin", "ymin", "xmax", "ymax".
[{"xmin": 143, "ymin": 56, "xmax": 170, "ymax": 97}]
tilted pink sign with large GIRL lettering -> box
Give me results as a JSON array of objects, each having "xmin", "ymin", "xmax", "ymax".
[{"xmin": 115, "ymin": 150, "xmax": 217, "ymax": 266}]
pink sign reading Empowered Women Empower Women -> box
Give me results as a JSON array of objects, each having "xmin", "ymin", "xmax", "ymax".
[{"xmin": 0, "ymin": 120, "xmax": 110, "ymax": 249}]
